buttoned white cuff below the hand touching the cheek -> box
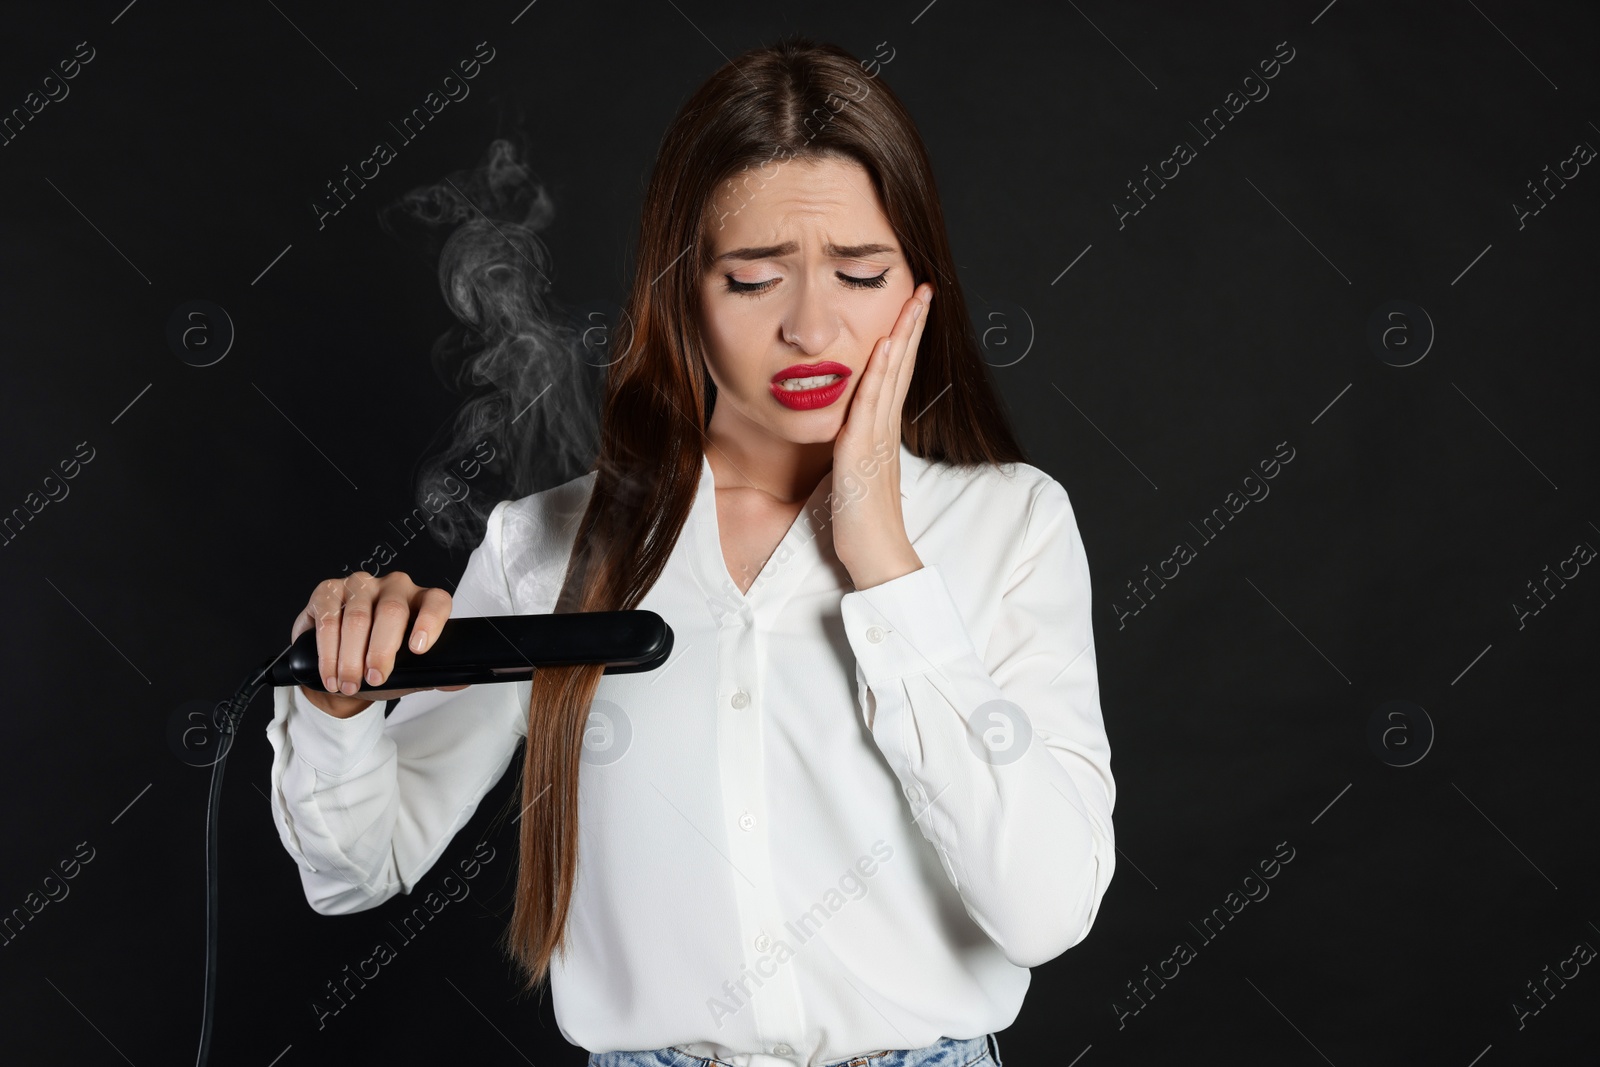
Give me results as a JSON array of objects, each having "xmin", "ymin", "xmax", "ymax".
[{"xmin": 840, "ymin": 563, "xmax": 978, "ymax": 688}]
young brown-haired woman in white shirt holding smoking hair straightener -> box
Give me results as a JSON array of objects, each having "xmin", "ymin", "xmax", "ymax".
[{"xmin": 267, "ymin": 33, "xmax": 1115, "ymax": 1067}]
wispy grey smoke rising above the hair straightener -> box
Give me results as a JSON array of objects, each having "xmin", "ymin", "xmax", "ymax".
[{"xmin": 381, "ymin": 139, "xmax": 603, "ymax": 549}]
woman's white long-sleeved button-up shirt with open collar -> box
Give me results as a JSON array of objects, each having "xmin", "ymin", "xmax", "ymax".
[{"xmin": 267, "ymin": 443, "xmax": 1115, "ymax": 1067}]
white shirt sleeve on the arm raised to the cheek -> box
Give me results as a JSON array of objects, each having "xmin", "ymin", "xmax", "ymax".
[{"xmin": 840, "ymin": 478, "xmax": 1115, "ymax": 966}]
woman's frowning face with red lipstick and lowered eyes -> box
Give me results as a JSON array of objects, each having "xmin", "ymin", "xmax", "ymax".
[{"xmin": 699, "ymin": 158, "xmax": 915, "ymax": 445}]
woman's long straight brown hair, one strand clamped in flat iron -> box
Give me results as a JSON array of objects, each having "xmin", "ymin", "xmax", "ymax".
[{"xmin": 506, "ymin": 37, "xmax": 1026, "ymax": 992}]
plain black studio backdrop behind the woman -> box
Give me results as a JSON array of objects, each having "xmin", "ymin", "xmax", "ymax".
[{"xmin": 0, "ymin": 0, "xmax": 1600, "ymax": 1067}]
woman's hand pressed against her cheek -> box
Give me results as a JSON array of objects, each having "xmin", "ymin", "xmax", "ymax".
[{"xmin": 832, "ymin": 283, "xmax": 933, "ymax": 589}]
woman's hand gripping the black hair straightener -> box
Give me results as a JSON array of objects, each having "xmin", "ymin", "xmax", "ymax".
[{"xmin": 290, "ymin": 571, "xmax": 467, "ymax": 718}]
